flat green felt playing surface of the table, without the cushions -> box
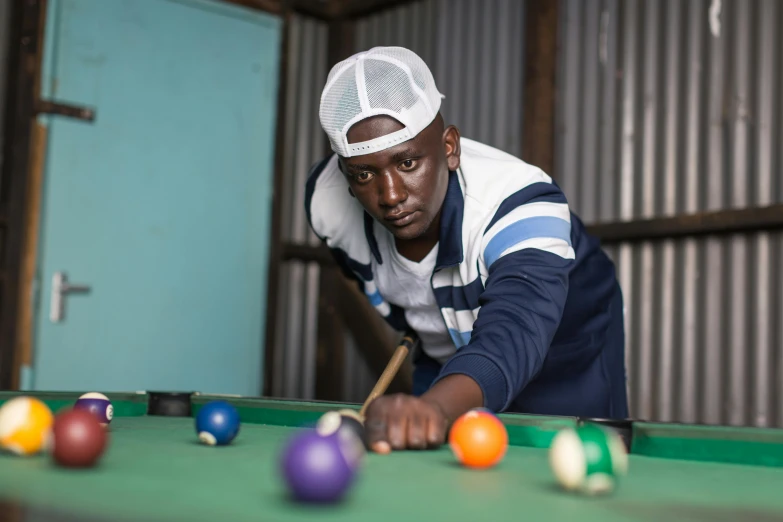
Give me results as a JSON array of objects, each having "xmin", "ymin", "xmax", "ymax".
[{"xmin": 0, "ymin": 416, "xmax": 783, "ymax": 522}]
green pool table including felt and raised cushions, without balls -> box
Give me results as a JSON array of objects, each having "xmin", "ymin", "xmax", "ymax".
[{"xmin": 0, "ymin": 392, "xmax": 783, "ymax": 522}]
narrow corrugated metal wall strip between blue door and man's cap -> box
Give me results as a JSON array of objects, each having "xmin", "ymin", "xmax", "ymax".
[{"xmin": 272, "ymin": 16, "xmax": 328, "ymax": 399}]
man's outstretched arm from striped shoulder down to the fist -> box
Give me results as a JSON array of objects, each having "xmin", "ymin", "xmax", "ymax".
[{"xmin": 368, "ymin": 183, "xmax": 574, "ymax": 452}]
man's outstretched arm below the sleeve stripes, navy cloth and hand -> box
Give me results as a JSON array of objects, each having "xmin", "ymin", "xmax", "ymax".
[{"xmin": 365, "ymin": 251, "xmax": 570, "ymax": 453}]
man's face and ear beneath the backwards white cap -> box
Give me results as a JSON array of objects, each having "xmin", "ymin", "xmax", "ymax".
[{"xmin": 340, "ymin": 115, "xmax": 459, "ymax": 240}]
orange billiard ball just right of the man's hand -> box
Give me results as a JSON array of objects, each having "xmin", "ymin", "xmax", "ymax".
[{"xmin": 449, "ymin": 410, "xmax": 508, "ymax": 468}]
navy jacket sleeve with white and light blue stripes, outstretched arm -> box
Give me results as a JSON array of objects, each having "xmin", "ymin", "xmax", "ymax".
[{"xmin": 436, "ymin": 179, "xmax": 575, "ymax": 411}]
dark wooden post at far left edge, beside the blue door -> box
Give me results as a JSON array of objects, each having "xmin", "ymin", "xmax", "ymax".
[{"xmin": 0, "ymin": 0, "xmax": 46, "ymax": 389}]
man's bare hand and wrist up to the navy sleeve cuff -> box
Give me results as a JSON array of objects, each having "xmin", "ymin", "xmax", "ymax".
[{"xmin": 364, "ymin": 375, "xmax": 484, "ymax": 453}]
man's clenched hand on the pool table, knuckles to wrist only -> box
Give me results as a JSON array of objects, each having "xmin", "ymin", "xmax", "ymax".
[{"xmin": 364, "ymin": 393, "xmax": 449, "ymax": 453}]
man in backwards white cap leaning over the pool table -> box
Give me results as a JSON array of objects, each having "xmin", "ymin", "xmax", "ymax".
[{"xmin": 305, "ymin": 47, "xmax": 627, "ymax": 453}]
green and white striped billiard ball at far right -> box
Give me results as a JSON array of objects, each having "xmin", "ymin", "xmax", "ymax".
[{"xmin": 549, "ymin": 424, "xmax": 628, "ymax": 495}]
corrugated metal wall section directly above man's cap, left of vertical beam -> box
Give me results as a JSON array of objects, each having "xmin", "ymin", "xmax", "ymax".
[{"xmin": 356, "ymin": 0, "xmax": 525, "ymax": 155}]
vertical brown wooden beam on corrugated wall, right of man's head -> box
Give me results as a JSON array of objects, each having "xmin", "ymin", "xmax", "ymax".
[{"xmin": 522, "ymin": 0, "xmax": 558, "ymax": 176}]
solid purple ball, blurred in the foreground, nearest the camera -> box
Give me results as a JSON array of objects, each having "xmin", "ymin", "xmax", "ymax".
[{"xmin": 281, "ymin": 430, "xmax": 354, "ymax": 503}]
